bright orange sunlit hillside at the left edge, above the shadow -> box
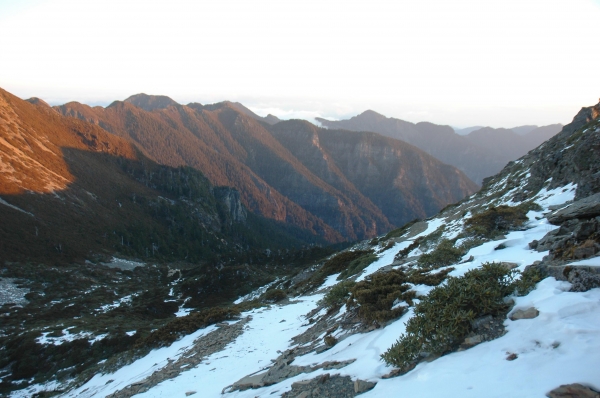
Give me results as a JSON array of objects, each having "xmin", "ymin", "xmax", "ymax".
[{"xmin": 0, "ymin": 89, "xmax": 135, "ymax": 194}]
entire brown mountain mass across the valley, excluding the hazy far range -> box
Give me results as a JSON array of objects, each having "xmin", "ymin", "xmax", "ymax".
[{"xmin": 0, "ymin": 87, "xmax": 477, "ymax": 260}]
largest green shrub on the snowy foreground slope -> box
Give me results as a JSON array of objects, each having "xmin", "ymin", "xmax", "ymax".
[{"xmin": 382, "ymin": 263, "xmax": 516, "ymax": 368}]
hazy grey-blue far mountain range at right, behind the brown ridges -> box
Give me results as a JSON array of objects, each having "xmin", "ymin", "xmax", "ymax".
[{"xmin": 317, "ymin": 110, "xmax": 562, "ymax": 184}]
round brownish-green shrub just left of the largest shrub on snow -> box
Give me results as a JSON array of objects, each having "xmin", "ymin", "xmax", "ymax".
[{"xmin": 348, "ymin": 270, "xmax": 415, "ymax": 323}]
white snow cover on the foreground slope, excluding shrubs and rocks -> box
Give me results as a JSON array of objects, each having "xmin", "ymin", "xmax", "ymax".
[{"xmin": 48, "ymin": 180, "xmax": 600, "ymax": 397}]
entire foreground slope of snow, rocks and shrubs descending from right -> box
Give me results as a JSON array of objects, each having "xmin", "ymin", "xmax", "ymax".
[{"xmin": 11, "ymin": 104, "xmax": 600, "ymax": 398}]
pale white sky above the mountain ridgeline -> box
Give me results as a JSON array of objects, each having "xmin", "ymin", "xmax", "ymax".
[{"xmin": 0, "ymin": 0, "xmax": 600, "ymax": 127}]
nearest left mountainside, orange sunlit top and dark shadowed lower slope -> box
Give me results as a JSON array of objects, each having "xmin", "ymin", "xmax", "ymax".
[{"xmin": 0, "ymin": 90, "xmax": 332, "ymax": 263}]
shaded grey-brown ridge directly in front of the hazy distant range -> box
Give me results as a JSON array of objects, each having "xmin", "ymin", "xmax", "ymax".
[{"xmin": 272, "ymin": 120, "xmax": 477, "ymax": 225}]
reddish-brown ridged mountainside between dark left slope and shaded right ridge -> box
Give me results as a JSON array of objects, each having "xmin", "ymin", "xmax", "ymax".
[{"xmin": 57, "ymin": 98, "xmax": 384, "ymax": 242}]
